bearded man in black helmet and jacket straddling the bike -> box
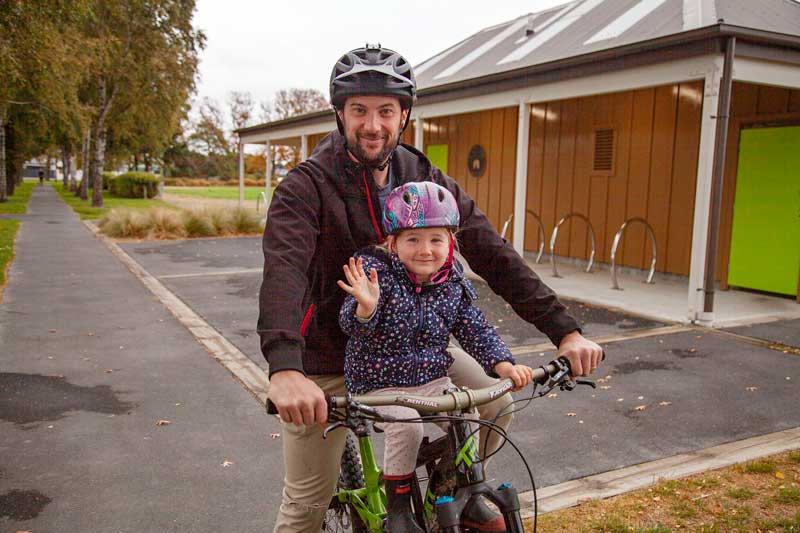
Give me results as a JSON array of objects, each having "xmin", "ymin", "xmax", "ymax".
[{"xmin": 258, "ymin": 45, "xmax": 602, "ymax": 532}]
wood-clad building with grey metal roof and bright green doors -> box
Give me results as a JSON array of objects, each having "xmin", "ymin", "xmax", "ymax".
[{"xmin": 239, "ymin": 0, "xmax": 800, "ymax": 324}]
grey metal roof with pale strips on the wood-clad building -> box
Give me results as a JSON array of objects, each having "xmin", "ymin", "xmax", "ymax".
[{"xmin": 414, "ymin": 0, "xmax": 800, "ymax": 91}]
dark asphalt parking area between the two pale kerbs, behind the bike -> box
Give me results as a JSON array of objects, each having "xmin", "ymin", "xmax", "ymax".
[{"xmin": 121, "ymin": 238, "xmax": 800, "ymax": 502}]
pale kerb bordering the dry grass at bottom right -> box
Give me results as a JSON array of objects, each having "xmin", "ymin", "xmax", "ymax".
[{"xmin": 520, "ymin": 428, "xmax": 800, "ymax": 518}]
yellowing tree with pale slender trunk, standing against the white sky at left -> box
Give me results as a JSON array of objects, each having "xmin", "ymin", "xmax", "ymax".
[{"xmin": 83, "ymin": 0, "xmax": 205, "ymax": 206}]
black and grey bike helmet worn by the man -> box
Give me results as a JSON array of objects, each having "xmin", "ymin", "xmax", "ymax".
[{"xmin": 331, "ymin": 44, "xmax": 417, "ymax": 109}]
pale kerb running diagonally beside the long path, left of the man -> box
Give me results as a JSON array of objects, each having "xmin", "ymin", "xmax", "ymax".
[{"xmin": 84, "ymin": 221, "xmax": 269, "ymax": 404}]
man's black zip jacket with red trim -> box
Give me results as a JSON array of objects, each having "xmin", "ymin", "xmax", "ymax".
[{"xmin": 258, "ymin": 131, "xmax": 579, "ymax": 375}]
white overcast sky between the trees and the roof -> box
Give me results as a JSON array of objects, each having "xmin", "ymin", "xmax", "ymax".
[{"xmin": 195, "ymin": 0, "xmax": 566, "ymax": 120}]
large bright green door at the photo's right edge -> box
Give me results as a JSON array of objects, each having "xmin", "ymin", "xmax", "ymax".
[{"xmin": 728, "ymin": 127, "xmax": 800, "ymax": 295}]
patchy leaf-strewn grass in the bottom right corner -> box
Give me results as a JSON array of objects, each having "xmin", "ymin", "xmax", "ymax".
[{"xmin": 525, "ymin": 451, "xmax": 800, "ymax": 533}]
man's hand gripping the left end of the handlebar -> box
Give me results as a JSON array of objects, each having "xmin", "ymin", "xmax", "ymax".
[{"xmin": 268, "ymin": 370, "xmax": 328, "ymax": 426}]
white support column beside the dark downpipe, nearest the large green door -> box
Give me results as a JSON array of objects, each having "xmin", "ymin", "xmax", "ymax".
[{"xmin": 687, "ymin": 54, "xmax": 724, "ymax": 325}]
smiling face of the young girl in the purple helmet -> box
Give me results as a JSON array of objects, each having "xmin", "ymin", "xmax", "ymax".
[{"xmin": 390, "ymin": 228, "xmax": 450, "ymax": 282}]
